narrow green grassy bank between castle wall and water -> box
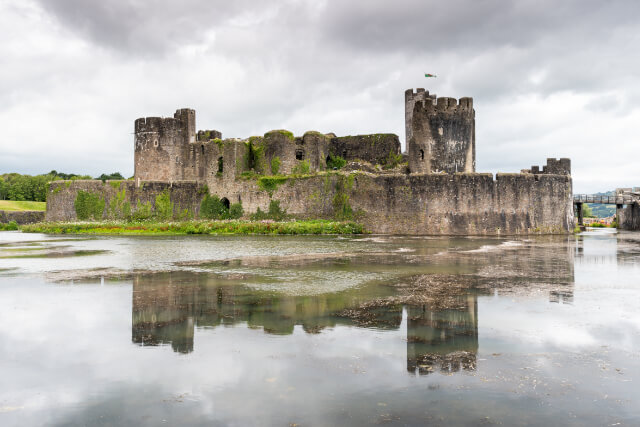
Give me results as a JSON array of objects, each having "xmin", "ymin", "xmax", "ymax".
[{"xmin": 20, "ymin": 220, "xmax": 366, "ymax": 235}]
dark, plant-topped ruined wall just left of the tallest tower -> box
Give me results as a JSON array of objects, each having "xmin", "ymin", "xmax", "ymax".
[{"xmin": 329, "ymin": 133, "xmax": 400, "ymax": 164}]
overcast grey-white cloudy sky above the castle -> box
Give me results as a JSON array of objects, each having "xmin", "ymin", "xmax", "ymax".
[{"xmin": 0, "ymin": 0, "xmax": 640, "ymax": 192}]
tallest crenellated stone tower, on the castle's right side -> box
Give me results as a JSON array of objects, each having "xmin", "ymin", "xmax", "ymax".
[{"xmin": 406, "ymin": 94, "xmax": 475, "ymax": 173}]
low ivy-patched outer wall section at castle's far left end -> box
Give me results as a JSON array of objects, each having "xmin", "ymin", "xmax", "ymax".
[{"xmin": 45, "ymin": 180, "xmax": 204, "ymax": 221}]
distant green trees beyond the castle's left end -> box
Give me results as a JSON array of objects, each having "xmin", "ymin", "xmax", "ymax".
[{"xmin": 0, "ymin": 170, "xmax": 124, "ymax": 202}]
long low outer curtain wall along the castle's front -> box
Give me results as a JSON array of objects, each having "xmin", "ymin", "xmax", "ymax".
[{"xmin": 46, "ymin": 172, "xmax": 574, "ymax": 235}]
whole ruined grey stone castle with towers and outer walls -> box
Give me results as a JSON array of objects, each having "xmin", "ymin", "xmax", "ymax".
[{"xmin": 47, "ymin": 89, "xmax": 574, "ymax": 235}]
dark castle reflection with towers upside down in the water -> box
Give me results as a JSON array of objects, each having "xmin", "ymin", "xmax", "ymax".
[{"xmin": 132, "ymin": 234, "xmax": 574, "ymax": 375}]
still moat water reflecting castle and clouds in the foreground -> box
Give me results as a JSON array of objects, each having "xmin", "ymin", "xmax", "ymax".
[{"xmin": 0, "ymin": 231, "xmax": 640, "ymax": 426}]
